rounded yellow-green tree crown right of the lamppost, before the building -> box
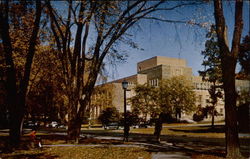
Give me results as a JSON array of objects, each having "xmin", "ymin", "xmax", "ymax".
[{"xmin": 157, "ymin": 76, "xmax": 196, "ymax": 118}]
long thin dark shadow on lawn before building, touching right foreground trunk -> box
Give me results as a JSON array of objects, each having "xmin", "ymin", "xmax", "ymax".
[{"xmin": 169, "ymin": 125, "xmax": 225, "ymax": 133}]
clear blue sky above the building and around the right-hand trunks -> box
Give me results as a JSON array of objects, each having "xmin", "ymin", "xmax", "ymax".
[{"xmin": 104, "ymin": 1, "xmax": 250, "ymax": 81}]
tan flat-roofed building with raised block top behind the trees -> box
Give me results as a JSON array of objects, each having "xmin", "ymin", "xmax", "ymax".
[{"xmin": 92, "ymin": 56, "xmax": 250, "ymax": 120}]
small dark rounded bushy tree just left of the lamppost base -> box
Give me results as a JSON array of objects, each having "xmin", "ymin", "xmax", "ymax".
[{"xmin": 99, "ymin": 107, "xmax": 120, "ymax": 125}]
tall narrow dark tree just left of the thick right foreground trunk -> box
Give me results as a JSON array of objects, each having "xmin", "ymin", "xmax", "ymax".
[{"xmin": 199, "ymin": 25, "xmax": 223, "ymax": 128}]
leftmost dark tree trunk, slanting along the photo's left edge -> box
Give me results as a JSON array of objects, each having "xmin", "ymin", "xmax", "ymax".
[{"xmin": 0, "ymin": 2, "xmax": 20, "ymax": 146}]
